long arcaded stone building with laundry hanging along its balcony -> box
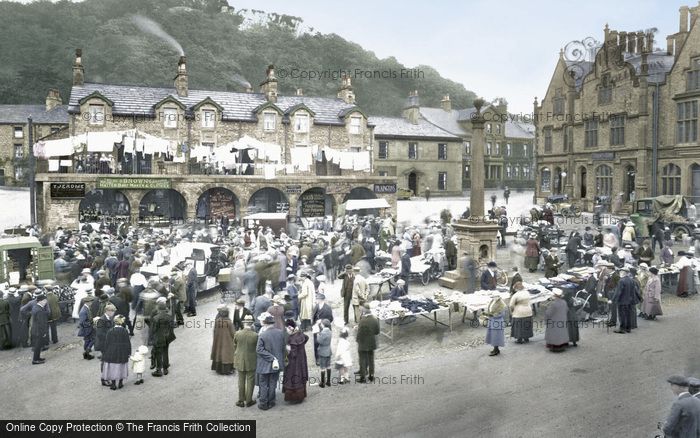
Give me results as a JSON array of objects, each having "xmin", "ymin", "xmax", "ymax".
[{"xmin": 36, "ymin": 50, "xmax": 396, "ymax": 229}]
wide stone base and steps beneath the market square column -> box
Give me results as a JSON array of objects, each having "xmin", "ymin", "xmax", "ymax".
[{"xmin": 438, "ymin": 218, "xmax": 501, "ymax": 291}]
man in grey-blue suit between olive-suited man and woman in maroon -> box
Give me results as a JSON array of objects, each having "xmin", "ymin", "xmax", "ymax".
[{"xmin": 255, "ymin": 314, "xmax": 284, "ymax": 411}]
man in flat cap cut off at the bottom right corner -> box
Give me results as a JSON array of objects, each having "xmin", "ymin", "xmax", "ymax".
[{"xmin": 663, "ymin": 376, "xmax": 700, "ymax": 438}]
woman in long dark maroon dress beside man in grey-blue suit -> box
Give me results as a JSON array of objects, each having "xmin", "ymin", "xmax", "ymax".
[{"xmin": 282, "ymin": 319, "xmax": 309, "ymax": 404}]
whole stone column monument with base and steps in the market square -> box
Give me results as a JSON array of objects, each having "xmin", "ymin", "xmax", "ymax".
[{"xmin": 439, "ymin": 99, "xmax": 500, "ymax": 291}]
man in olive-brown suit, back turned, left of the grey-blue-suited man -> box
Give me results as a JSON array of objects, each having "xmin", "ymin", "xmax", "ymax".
[{"xmin": 233, "ymin": 314, "xmax": 258, "ymax": 408}]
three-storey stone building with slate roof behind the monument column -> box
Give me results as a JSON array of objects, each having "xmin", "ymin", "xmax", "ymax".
[{"xmin": 406, "ymin": 93, "xmax": 534, "ymax": 189}]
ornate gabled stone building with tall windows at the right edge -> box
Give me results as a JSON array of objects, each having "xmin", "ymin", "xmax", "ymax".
[{"xmin": 534, "ymin": 6, "xmax": 700, "ymax": 211}]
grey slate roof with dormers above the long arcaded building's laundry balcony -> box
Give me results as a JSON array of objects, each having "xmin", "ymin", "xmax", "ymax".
[{"xmin": 68, "ymin": 83, "xmax": 356, "ymax": 125}]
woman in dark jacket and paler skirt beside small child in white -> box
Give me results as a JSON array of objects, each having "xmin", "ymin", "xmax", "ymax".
[{"xmin": 102, "ymin": 315, "xmax": 131, "ymax": 390}]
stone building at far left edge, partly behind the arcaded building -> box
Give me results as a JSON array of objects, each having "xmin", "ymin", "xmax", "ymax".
[{"xmin": 0, "ymin": 90, "xmax": 68, "ymax": 186}]
